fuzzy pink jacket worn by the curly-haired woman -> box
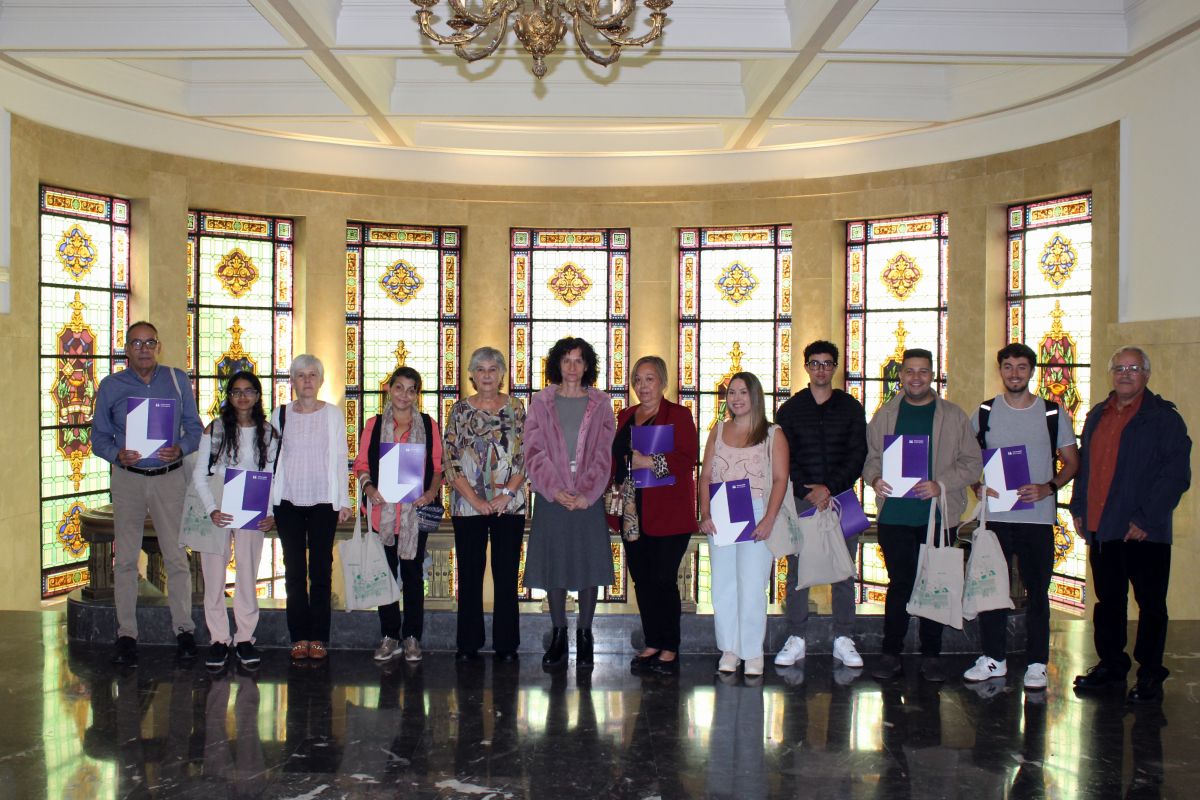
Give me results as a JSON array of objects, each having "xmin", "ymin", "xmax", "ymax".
[{"xmin": 524, "ymin": 385, "xmax": 617, "ymax": 505}]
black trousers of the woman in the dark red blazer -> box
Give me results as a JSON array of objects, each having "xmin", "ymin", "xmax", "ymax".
[{"xmin": 625, "ymin": 534, "xmax": 691, "ymax": 652}]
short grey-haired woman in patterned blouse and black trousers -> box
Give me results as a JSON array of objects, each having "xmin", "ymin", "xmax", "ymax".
[{"xmin": 443, "ymin": 347, "xmax": 526, "ymax": 661}]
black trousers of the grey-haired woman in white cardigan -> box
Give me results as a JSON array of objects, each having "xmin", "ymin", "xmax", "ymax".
[{"xmin": 275, "ymin": 500, "xmax": 337, "ymax": 643}]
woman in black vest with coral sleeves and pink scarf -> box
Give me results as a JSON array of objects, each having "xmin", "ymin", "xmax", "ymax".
[{"xmin": 354, "ymin": 367, "xmax": 442, "ymax": 661}]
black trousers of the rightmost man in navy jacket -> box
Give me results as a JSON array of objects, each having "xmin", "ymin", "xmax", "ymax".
[{"xmin": 1088, "ymin": 540, "xmax": 1171, "ymax": 679}]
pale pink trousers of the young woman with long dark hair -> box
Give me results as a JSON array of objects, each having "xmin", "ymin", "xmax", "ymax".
[{"xmin": 197, "ymin": 529, "xmax": 263, "ymax": 644}]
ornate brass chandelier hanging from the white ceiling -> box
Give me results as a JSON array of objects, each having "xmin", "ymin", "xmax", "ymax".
[{"xmin": 413, "ymin": 0, "xmax": 673, "ymax": 79}]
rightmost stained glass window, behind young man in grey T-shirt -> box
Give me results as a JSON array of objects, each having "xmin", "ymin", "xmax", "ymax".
[{"xmin": 1004, "ymin": 194, "xmax": 1092, "ymax": 613}]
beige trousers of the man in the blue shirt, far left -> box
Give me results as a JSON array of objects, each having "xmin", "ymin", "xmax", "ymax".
[{"xmin": 112, "ymin": 467, "xmax": 196, "ymax": 639}]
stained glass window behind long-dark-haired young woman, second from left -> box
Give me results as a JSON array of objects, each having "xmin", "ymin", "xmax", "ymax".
[{"xmin": 187, "ymin": 211, "xmax": 295, "ymax": 597}]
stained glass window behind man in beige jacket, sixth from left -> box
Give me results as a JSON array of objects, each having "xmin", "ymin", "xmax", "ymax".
[{"xmin": 844, "ymin": 213, "xmax": 949, "ymax": 602}]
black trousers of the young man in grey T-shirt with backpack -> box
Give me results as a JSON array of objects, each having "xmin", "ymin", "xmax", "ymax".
[{"xmin": 979, "ymin": 522, "xmax": 1054, "ymax": 664}]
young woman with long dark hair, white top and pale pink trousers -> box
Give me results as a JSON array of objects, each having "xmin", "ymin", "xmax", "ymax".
[{"xmin": 192, "ymin": 372, "xmax": 280, "ymax": 669}]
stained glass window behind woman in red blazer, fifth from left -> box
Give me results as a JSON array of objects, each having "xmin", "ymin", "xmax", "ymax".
[{"xmin": 679, "ymin": 225, "xmax": 792, "ymax": 457}]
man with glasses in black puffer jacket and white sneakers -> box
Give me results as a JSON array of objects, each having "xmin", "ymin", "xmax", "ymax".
[{"xmin": 775, "ymin": 341, "xmax": 866, "ymax": 668}]
